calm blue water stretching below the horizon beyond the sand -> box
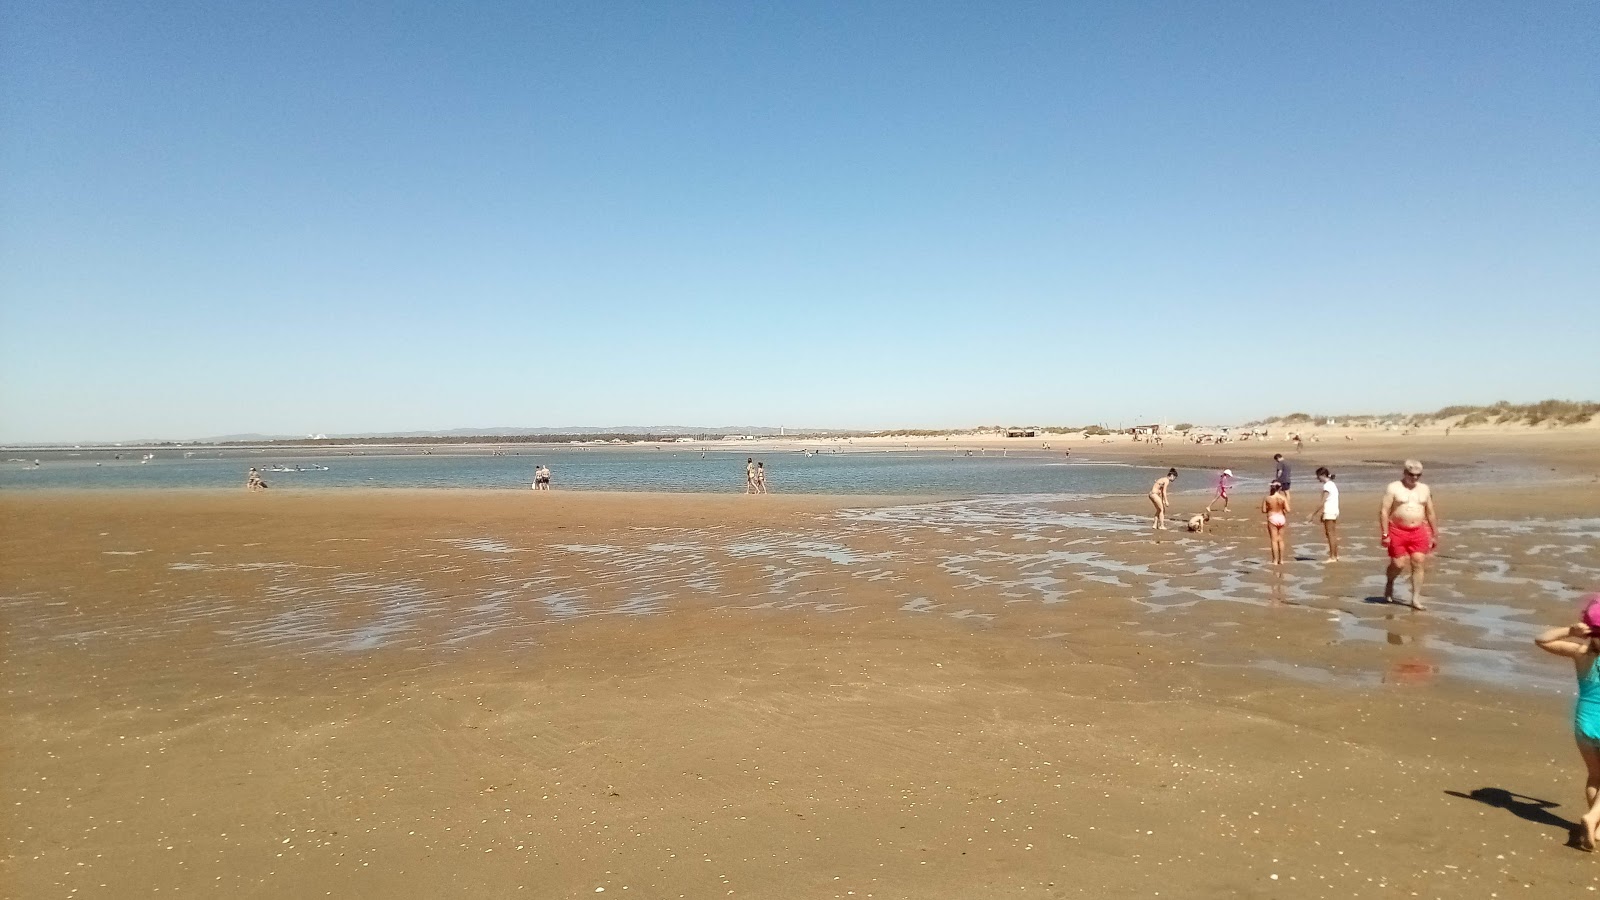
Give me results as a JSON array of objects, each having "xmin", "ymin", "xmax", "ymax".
[{"xmin": 0, "ymin": 447, "xmax": 1209, "ymax": 496}]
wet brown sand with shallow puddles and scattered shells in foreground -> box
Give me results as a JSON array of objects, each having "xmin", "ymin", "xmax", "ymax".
[{"xmin": 0, "ymin": 480, "xmax": 1600, "ymax": 898}]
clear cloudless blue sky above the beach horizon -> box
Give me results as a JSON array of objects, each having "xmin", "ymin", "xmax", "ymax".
[{"xmin": 0, "ymin": 0, "xmax": 1600, "ymax": 442}]
